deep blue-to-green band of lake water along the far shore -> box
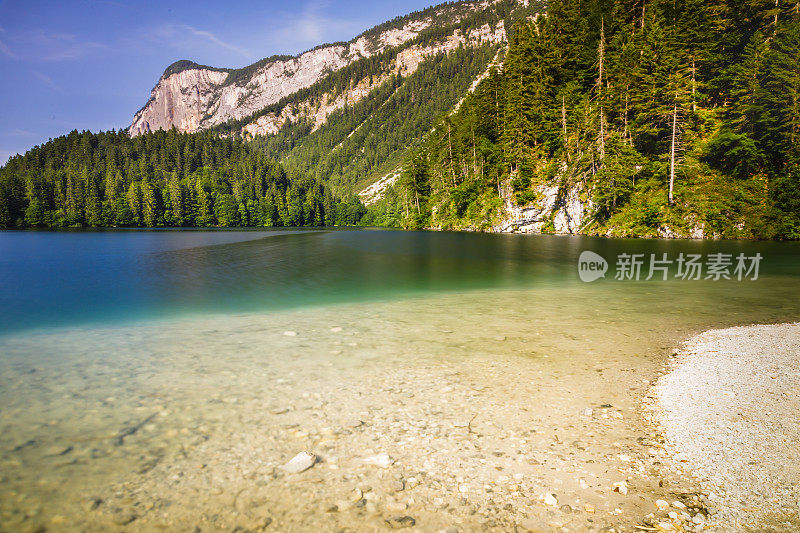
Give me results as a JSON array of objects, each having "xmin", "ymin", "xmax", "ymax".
[{"xmin": 0, "ymin": 225, "xmax": 800, "ymax": 334}]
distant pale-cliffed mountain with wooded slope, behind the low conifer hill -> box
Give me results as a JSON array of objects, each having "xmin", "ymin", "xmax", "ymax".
[{"xmin": 129, "ymin": 0, "xmax": 542, "ymax": 200}]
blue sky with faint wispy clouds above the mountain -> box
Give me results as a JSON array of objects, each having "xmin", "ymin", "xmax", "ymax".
[{"xmin": 0, "ymin": 0, "xmax": 438, "ymax": 165}]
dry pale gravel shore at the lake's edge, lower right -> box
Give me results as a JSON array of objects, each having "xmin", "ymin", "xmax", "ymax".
[{"xmin": 651, "ymin": 323, "xmax": 800, "ymax": 531}]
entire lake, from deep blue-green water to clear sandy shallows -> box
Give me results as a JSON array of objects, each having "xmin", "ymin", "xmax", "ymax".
[{"xmin": 0, "ymin": 229, "xmax": 800, "ymax": 531}]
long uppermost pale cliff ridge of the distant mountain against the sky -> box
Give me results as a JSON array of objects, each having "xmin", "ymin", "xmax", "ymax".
[{"xmin": 128, "ymin": 0, "xmax": 510, "ymax": 136}]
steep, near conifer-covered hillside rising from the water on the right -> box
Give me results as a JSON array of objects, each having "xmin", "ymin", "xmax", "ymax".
[{"xmin": 376, "ymin": 0, "xmax": 800, "ymax": 238}]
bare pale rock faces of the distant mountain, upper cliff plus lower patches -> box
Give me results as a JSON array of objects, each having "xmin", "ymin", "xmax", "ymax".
[{"xmin": 129, "ymin": 1, "xmax": 505, "ymax": 135}]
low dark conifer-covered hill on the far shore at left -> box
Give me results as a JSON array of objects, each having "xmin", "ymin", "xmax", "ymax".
[{"xmin": 0, "ymin": 130, "xmax": 364, "ymax": 227}]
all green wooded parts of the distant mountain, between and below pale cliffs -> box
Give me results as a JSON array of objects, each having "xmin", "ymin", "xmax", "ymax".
[{"xmin": 214, "ymin": 0, "xmax": 543, "ymax": 193}]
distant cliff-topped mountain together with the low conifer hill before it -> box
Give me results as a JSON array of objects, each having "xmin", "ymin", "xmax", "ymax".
[{"xmin": 0, "ymin": 0, "xmax": 540, "ymax": 227}]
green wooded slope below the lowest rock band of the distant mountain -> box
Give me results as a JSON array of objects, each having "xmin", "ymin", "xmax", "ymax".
[{"xmin": 254, "ymin": 45, "xmax": 498, "ymax": 191}]
